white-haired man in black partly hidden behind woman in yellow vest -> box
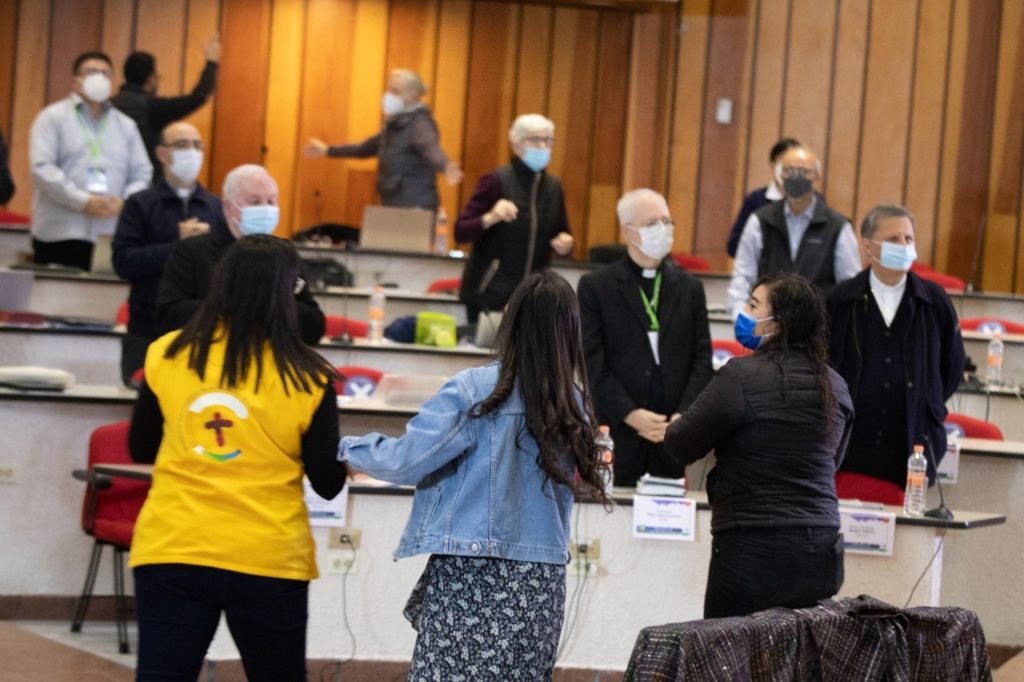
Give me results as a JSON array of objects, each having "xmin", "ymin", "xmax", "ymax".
[{"xmin": 157, "ymin": 164, "xmax": 324, "ymax": 345}]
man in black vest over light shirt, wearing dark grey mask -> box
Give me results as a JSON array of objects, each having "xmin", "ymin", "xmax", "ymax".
[{"xmin": 729, "ymin": 147, "xmax": 861, "ymax": 317}]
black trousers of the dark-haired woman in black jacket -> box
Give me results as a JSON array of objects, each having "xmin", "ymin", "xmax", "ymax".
[{"xmin": 705, "ymin": 526, "xmax": 843, "ymax": 619}]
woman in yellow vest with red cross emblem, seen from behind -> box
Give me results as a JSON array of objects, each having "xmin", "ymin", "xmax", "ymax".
[{"xmin": 129, "ymin": 236, "xmax": 346, "ymax": 682}]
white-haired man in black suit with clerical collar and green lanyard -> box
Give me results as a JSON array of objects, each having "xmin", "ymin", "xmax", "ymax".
[{"xmin": 578, "ymin": 189, "xmax": 712, "ymax": 485}]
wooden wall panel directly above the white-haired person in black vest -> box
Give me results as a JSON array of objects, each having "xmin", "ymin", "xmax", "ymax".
[{"xmin": 513, "ymin": 5, "xmax": 555, "ymax": 116}]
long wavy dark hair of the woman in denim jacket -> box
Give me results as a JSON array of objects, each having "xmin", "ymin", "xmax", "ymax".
[{"xmin": 470, "ymin": 270, "xmax": 610, "ymax": 506}]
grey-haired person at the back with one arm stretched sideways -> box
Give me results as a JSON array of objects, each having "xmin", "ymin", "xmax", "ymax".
[{"xmin": 306, "ymin": 69, "xmax": 462, "ymax": 211}]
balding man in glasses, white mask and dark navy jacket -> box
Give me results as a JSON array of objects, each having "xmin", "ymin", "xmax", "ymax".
[{"xmin": 113, "ymin": 121, "xmax": 227, "ymax": 384}]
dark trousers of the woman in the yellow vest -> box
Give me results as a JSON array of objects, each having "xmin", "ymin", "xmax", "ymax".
[{"xmin": 134, "ymin": 563, "xmax": 309, "ymax": 682}]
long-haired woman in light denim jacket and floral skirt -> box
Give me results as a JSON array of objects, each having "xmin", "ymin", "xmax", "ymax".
[{"xmin": 339, "ymin": 271, "xmax": 608, "ymax": 680}]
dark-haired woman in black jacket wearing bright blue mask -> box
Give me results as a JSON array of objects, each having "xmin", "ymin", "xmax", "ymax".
[{"xmin": 665, "ymin": 274, "xmax": 853, "ymax": 617}]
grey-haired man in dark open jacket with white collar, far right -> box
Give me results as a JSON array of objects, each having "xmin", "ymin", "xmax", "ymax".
[{"xmin": 827, "ymin": 204, "xmax": 965, "ymax": 487}]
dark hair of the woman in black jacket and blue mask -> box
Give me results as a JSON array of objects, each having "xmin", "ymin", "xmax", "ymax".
[{"xmin": 752, "ymin": 274, "xmax": 836, "ymax": 433}]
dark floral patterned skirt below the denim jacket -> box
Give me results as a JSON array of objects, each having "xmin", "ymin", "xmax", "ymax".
[{"xmin": 404, "ymin": 554, "xmax": 565, "ymax": 682}]
